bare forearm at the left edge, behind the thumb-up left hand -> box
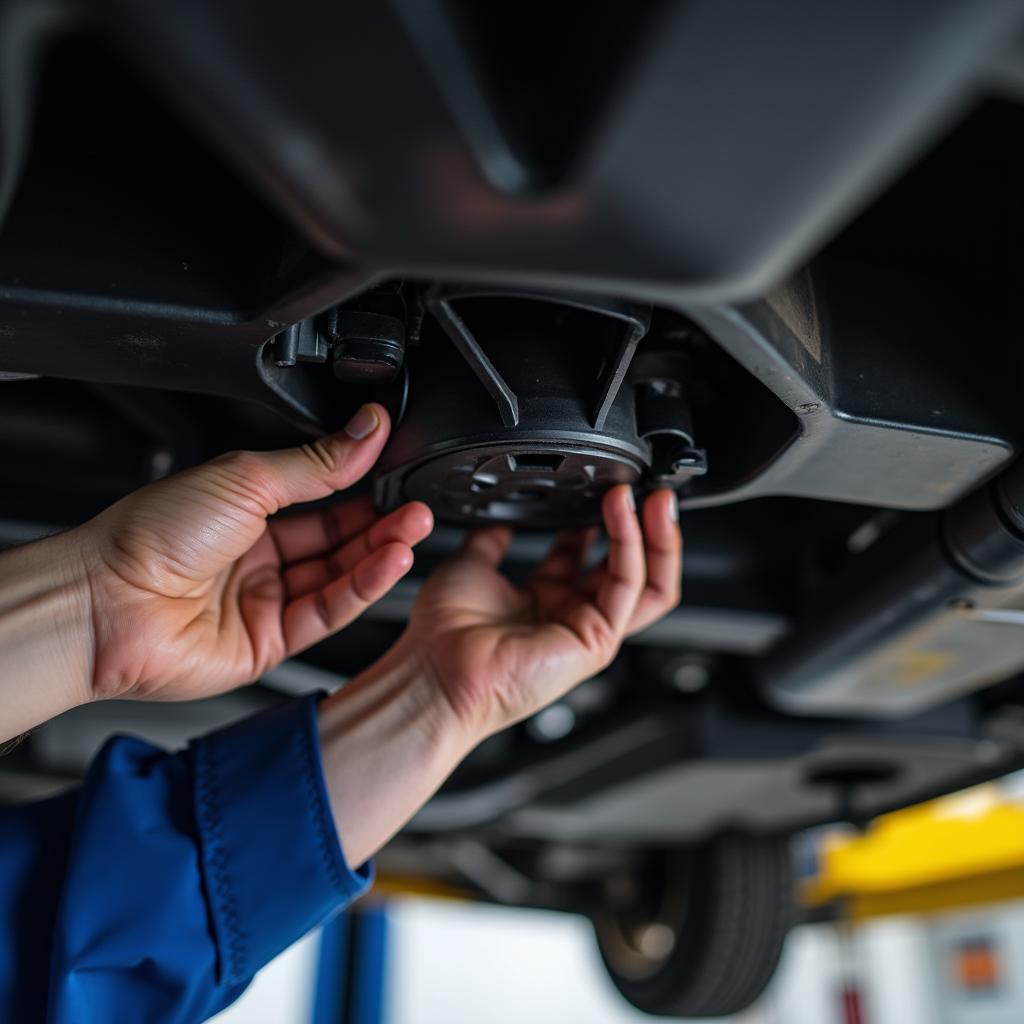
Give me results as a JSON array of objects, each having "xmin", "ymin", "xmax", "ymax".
[{"xmin": 0, "ymin": 531, "xmax": 93, "ymax": 740}]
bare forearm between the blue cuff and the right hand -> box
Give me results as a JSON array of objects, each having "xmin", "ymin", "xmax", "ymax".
[{"xmin": 319, "ymin": 646, "xmax": 475, "ymax": 866}]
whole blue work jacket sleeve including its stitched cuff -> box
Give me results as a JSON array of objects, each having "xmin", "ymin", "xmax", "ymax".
[{"xmin": 0, "ymin": 698, "xmax": 370, "ymax": 1024}]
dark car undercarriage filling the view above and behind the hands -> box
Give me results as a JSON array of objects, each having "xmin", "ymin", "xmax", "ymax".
[{"xmin": 0, "ymin": 0, "xmax": 1024, "ymax": 1014}]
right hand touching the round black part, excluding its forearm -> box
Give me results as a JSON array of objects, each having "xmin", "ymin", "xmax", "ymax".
[{"xmin": 399, "ymin": 486, "xmax": 682, "ymax": 736}]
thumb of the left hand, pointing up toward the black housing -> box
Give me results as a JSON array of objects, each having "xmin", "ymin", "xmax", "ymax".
[{"xmin": 212, "ymin": 403, "xmax": 390, "ymax": 515}]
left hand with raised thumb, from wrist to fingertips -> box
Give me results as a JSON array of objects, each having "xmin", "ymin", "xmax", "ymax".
[{"xmin": 83, "ymin": 404, "xmax": 433, "ymax": 699}]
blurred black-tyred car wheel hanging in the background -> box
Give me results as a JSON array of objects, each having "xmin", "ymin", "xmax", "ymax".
[{"xmin": 594, "ymin": 835, "xmax": 793, "ymax": 1017}]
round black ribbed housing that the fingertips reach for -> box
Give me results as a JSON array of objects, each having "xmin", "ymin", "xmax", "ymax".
[{"xmin": 375, "ymin": 288, "xmax": 705, "ymax": 529}]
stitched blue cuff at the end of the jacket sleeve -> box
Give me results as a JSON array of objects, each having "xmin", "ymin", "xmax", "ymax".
[{"xmin": 191, "ymin": 695, "xmax": 373, "ymax": 984}]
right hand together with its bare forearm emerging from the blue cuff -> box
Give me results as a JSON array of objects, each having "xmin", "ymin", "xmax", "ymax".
[{"xmin": 307, "ymin": 486, "xmax": 682, "ymax": 863}]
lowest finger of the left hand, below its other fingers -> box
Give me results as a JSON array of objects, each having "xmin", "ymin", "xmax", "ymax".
[{"xmin": 283, "ymin": 543, "xmax": 413, "ymax": 655}]
